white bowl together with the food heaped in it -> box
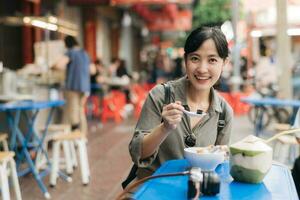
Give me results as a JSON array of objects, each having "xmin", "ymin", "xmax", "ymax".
[{"xmin": 184, "ymin": 145, "xmax": 227, "ymax": 171}]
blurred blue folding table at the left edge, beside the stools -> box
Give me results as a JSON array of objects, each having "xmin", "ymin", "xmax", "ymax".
[{"xmin": 0, "ymin": 100, "xmax": 65, "ymax": 197}]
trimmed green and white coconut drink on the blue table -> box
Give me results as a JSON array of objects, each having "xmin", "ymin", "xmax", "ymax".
[{"xmin": 229, "ymin": 135, "xmax": 273, "ymax": 183}]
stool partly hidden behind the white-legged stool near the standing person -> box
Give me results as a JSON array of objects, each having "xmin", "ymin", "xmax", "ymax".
[{"xmin": 36, "ymin": 124, "xmax": 78, "ymax": 175}]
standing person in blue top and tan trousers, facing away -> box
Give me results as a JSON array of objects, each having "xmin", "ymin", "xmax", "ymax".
[{"xmin": 52, "ymin": 36, "xmax": 91, "ymax": 134}]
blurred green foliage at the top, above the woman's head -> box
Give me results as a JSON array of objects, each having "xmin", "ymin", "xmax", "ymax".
[{"xmin": 193, "ymin": 0, "xmax": 231, "ymax": 27}]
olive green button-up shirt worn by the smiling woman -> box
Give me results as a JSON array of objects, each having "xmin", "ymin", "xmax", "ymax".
[{"xmin": 129, "ymin": 77, "xmax": 233, "ymax": 178}]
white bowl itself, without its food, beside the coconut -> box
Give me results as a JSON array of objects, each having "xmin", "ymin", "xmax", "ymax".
[{"xmin": 184, "ymin": 147, "xmax": 225, "ymax": 171}]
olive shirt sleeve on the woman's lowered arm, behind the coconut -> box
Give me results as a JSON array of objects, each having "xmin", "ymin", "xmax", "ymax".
[{"xmin": 216, "ymin": 104, "xmax": 233, "ymax": 145}]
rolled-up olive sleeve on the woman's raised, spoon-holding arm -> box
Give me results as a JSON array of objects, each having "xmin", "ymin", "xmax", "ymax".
[{"xmin": 129, "ymin": 85, "xmax": 164, "ymax": 167}]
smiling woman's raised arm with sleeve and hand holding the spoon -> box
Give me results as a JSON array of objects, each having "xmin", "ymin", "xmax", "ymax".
[{"xmin": 129, "ymin": 85, "xmax": 183, "ymax": 167}]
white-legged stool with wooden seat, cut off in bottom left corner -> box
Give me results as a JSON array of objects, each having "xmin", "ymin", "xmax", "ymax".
[{"xmin": 0, "ymin": 151, "xmax": 22, "ymax": 200}]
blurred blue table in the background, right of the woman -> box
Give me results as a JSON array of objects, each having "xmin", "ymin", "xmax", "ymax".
[{"xmin": 241, "ymin": 97, "xmax": 300, "ymax": 135}]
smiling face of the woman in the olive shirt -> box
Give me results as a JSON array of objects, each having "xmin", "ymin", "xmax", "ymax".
[{"xmin": 185, "ymin": 39, "xmax": 227, "ymax": 90}]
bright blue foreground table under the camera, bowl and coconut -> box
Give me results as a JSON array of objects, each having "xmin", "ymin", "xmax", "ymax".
[{"xmin": 133, "ymin": 160, "xmax": 298, "ymax": 200}]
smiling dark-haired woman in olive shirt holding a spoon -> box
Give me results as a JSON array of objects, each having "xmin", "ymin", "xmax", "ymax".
[{"xmin": 129, "ymin": 28, "xmax": 233, "ymax": 178}]
